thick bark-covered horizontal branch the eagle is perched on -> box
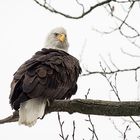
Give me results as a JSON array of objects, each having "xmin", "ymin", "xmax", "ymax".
[{"xmin": 0, "ymin": 99, "xmax": 140, "ymax": 124}]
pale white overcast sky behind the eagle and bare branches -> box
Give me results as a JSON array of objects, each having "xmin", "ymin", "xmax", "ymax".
[{"xmin": 0, "ymin": 0, "xmax": 140, "ymax": 140}]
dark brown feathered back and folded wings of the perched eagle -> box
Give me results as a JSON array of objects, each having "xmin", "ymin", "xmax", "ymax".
[{"xmin": 10, "ymin": 49, "xmax": 81, "ymax": 110}]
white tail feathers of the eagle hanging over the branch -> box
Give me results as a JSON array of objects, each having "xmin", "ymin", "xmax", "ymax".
[{"xmin": 19, "ymin": 98, "xmax": 46, "ymax": 127}]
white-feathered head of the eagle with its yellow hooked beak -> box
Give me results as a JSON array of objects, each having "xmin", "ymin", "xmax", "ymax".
[{"xmin": 45, "ymin": 27, "xmax": 69, "ymax": 52}]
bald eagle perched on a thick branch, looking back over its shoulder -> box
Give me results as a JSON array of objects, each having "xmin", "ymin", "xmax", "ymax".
[{"xmin": 9, "ymin": 27, "xmax": 81, "ymax": 127}]
